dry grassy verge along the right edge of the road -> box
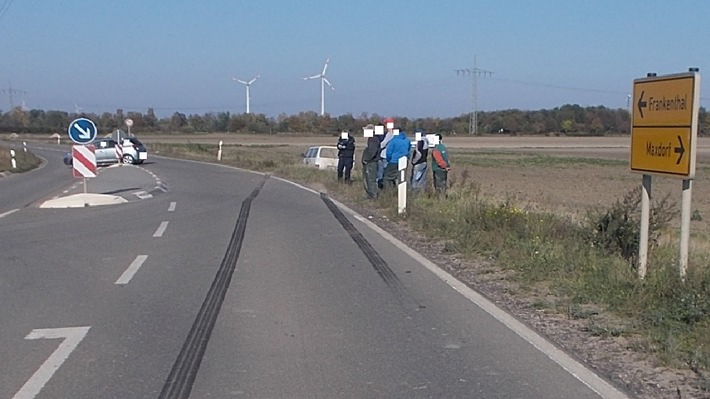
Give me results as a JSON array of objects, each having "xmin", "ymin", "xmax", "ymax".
[{"xmin": 152, "ymin": 144, "xmax": 710, "ymax": 386}]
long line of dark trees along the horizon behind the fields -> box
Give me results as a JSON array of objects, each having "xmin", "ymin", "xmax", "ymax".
[{"xmin": 0, "ymin": 104, "xmax": 710, "ymax": 136}]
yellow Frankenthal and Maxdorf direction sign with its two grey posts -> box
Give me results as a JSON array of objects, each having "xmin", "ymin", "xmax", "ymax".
[{"xmin": 630, "ymin": 68, "xmax": 700, "ymax": 279}]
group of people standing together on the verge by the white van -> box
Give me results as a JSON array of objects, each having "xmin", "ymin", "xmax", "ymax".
[{"xmin": 337, "ymin": 118, "xmax": 450, "ymax": 199}]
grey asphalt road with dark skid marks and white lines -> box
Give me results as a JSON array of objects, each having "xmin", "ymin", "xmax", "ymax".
[{"xmin": 0, "ymin": 143, "xmax": 636, "ymax": 399}]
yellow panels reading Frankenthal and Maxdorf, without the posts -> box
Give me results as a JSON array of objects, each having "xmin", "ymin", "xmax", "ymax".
[{"xmin": 630, "ymin": 71, "xmax": 700, "ymax": 179}]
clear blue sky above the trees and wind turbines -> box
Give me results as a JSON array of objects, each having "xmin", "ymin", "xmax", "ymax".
[{"xmin": 0, "ymin": 0, "xmax": 710, "ymax": 118}]
